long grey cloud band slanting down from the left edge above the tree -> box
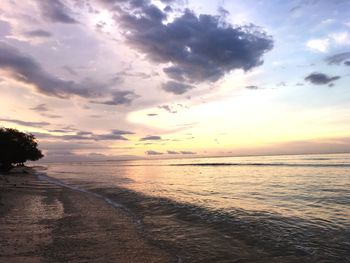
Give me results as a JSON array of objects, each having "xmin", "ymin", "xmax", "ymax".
[{"xmin": 0, "ymin": 42, "xmax": 138, "ymax": 105}]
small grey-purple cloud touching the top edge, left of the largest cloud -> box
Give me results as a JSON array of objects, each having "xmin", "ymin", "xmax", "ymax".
[{"xmin": 37, "ymin": 0, "xmax": 78, "ymax": 24}]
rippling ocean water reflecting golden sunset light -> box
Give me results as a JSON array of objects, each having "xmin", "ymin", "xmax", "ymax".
[{"xmin": 41, "ymin": 154, "xmax": 350, "ymax": 262}]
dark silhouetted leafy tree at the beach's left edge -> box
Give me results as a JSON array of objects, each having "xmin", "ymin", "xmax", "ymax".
[{"xmin": 0, "ymin": 128, "xmax": 44, "ymax": 171}]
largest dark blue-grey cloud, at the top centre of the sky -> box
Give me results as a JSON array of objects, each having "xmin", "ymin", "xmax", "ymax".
[{"xmin": 113, "ymin": 0, "xmax": 273, "ymax": 94}]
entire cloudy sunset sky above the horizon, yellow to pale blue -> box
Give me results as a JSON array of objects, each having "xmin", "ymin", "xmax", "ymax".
[{"xmin": 0, "ymin": 0, "xmax": 350, "ymax": 161}]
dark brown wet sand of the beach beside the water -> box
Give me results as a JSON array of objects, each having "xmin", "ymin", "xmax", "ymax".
[{"xmin": 0, "ymin": 170, "xmax": 177, "ymax": 263}]
